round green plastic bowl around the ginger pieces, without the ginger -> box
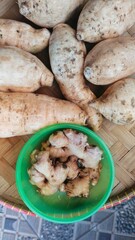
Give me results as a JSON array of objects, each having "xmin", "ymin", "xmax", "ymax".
[{"xmin": 16, "ymin": 123, "xmax": 115, "ymax": 223}]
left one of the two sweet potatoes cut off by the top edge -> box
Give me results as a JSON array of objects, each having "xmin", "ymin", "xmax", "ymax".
[{"xmin": 18, "ymin": 0, "xmax": 85, "ymax": 28}]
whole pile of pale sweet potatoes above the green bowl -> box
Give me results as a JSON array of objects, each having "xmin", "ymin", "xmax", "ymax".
[{"xmin": 0, "ymin": 0, "xmax": 135, "ymax": 138}]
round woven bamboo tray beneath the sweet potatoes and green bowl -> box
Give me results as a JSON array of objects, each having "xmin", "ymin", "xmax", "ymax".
[{"xmin": 0, "ymin": 0, "xmax": 135, "ymax": 214}]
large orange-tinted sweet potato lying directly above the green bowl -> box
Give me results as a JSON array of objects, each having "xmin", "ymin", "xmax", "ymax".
[{"xmin": 0, "ymin": 92, "xmax": 87, "ymax": 138}]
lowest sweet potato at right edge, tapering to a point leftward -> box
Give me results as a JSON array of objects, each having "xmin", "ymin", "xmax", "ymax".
[{"xmin": 90, "ymin": 78, "xmax": 135, "ymax": 125}]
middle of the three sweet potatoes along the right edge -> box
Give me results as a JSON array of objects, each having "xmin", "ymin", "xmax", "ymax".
[{"xmin": 84, "ymin": 36, "xmax": 135, "ymax": 85}]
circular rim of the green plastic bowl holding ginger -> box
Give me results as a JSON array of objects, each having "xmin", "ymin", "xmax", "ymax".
[{"xmin": 16, "ymin": 123, "xmax": 115, "ymax": 224}]
